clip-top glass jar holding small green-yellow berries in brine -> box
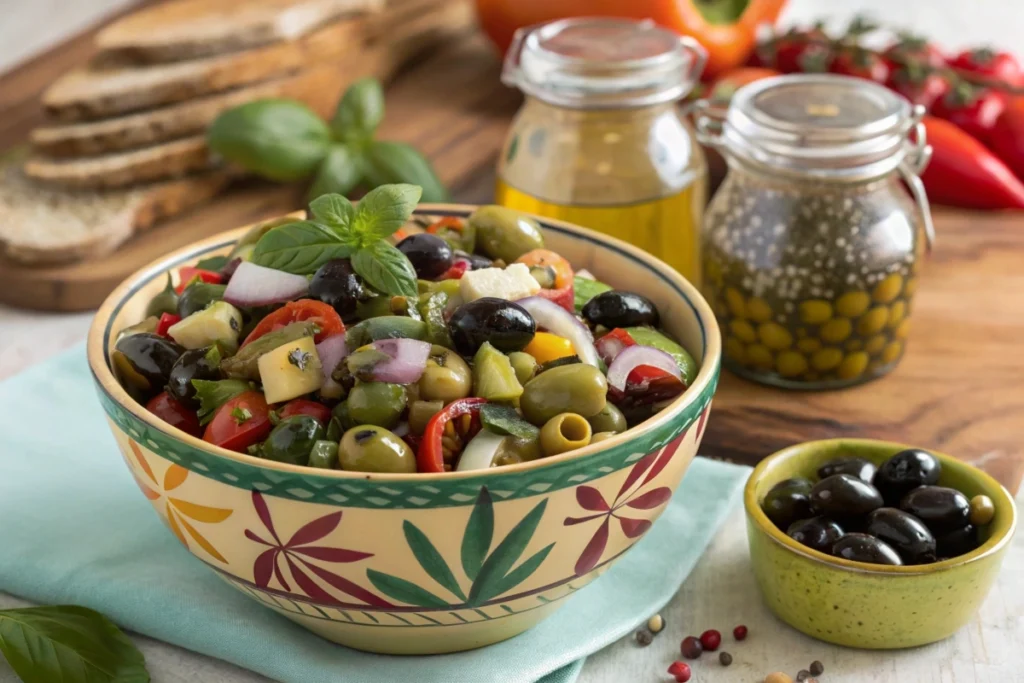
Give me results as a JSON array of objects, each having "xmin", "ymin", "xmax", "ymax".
[{"xmin": 697, "ymin": 75, "xmax": 933, "ymax": 389}]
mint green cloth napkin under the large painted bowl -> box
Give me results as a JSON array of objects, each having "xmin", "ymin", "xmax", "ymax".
[{"xmin": 0, "ymin": 347, "xmax": 749, "ymax": 683}]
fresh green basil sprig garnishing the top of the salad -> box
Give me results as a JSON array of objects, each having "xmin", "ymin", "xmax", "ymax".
[{"xmin": 252, "ymin": 184, "xmax": 422, "ymax": 297}]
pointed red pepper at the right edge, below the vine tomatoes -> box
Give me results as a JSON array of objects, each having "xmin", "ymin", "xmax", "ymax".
[{"xmin": 921, "ymin": 116, "xmax": 1024, "ymax": 209}]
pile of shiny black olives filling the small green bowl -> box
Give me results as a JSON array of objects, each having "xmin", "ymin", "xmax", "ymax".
[{"xmin": 761, "ymin": 449, "xmax": 994, "ymax": 565}]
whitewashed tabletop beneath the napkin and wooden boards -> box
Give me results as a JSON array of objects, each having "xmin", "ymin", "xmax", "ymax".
[{"xmin": 0, "ymin": 0, "xmax": 1024, "ymax": 683}]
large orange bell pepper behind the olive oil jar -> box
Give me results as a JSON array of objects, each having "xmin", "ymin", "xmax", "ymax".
[{"xmin": 476, "ymin": 0, "xmax": 785, "ymax": 80}]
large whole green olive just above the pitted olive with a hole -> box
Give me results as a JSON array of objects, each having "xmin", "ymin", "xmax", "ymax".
[{"xmin": 519, "ymin": 362, "xmax": 608, "ymax": 426}]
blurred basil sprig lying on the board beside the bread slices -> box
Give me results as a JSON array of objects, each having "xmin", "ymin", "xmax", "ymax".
[{"xmin": 207, "ymin": 78, "xmax": 449, "ymax": 202}]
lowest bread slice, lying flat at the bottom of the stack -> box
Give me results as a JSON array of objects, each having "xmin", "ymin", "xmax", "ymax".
[{"xmin": 0, "ymin": 161, "xmax": 232, "ymax": 266}]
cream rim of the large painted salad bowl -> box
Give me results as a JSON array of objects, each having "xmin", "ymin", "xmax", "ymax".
[{"xmin": 87, "ymin": 204, "xmax": 721, "ymax": 507}]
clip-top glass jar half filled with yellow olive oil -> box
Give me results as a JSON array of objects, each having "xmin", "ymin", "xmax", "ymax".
[{"xmin": 497, "ymin": 18, "xmax": 707, "ymax": 282}]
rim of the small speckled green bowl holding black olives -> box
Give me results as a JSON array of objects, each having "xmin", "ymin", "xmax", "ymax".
[{"xmin": 743, "ymin": 438, "xmax": 1017, "ymax": 577}]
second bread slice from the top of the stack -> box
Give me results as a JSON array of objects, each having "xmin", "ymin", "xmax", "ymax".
[{"xmin": 42, "ymin": 20, "xmax": 361, "ymax": 121}]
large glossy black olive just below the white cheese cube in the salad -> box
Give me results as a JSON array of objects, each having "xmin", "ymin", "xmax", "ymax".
[{"xmin": 449, "ymin": 297, "xmax": 537, "ymax": 355}]
